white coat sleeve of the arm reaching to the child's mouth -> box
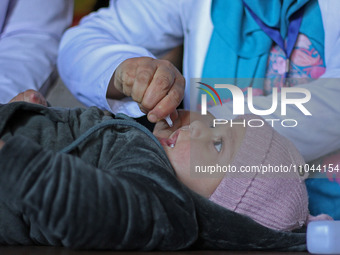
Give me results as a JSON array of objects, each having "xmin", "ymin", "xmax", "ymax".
[{"xmin": 58, "ymin": 0, "xmax": 183, "ymax": 117}]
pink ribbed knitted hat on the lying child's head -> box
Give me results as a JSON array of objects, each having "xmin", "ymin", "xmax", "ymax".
[{"xmin": 210, "ymin": 115, "xmax": 309, "ymax": 231}]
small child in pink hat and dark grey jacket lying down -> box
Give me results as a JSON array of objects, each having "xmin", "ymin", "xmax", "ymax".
[{"xmin": 0, "ymin": 91, "xmax": 327, "ymax": 250}]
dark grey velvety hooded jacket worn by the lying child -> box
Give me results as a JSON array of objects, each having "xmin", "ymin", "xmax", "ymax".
[{"xmin": 0, "ymin": 102, "xmax": 305, "ymax": 250}]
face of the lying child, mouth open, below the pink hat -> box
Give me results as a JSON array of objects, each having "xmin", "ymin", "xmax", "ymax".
[{"xmin": 154, "ymin": 112, "xmax": 244, "ymax": 197}]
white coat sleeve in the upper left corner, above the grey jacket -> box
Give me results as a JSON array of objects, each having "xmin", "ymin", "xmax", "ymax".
[{"xmin": 0, "ymin": 0, "xmax": 73, "ymax": 103}]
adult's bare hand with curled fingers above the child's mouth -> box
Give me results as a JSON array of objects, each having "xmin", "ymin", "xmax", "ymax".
[{"xmin": 107, "ymin": 57, "xmax": 185, "ymax": 122}]
